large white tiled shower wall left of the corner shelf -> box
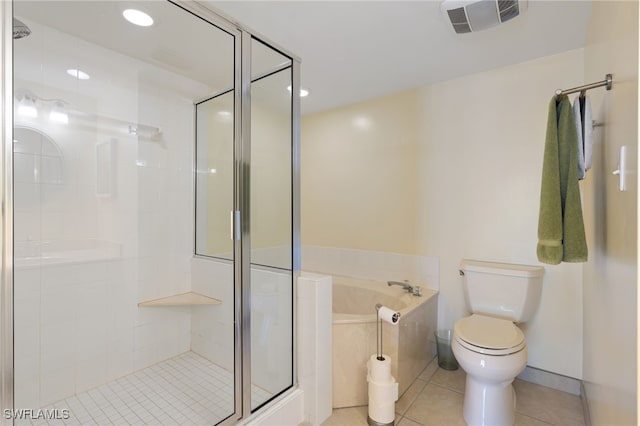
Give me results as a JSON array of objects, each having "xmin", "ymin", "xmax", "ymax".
[{"xmin": 14, "ymin": 19, "xmax": 198, "ymax": 408}]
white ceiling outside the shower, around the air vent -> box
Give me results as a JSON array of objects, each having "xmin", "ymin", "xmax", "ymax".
[{"xmin": 208, "ymin": 0, "xmax": 591, "ymax": 113}]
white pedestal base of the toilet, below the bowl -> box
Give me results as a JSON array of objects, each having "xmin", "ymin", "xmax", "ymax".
[{"xmin": 464, "ymin": 374, "xmax": 516, "ymax": 426}]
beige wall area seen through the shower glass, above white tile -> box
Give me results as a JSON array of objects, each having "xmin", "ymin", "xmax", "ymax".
[{"xmin": 196, "ymin": 81, "xmax": 291, "ymax": 268}]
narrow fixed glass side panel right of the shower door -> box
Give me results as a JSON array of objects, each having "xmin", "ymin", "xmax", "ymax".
[{"xmin": 251, "ymin": 40, "xmax": 293, "ymax": 409}]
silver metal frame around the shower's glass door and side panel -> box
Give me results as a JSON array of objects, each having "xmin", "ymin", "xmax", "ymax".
[{"xmin": 0, "ymin": 0, "xmax": 301, "ymax": 425}]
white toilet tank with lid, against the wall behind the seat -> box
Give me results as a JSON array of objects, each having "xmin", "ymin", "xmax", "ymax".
[{"xmin": 460, "ymin": 259, "xmax": 544, "ymax": 322}]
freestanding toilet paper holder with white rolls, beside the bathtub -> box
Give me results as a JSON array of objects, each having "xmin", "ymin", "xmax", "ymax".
[{"xmin": 367, "ymin": 303, "xmax": 400, "ymax": 426}]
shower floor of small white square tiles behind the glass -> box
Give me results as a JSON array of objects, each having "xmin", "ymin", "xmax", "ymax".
[{"xmin": 15, "ymin": 352, "xmax": 271, "ymax": 426}]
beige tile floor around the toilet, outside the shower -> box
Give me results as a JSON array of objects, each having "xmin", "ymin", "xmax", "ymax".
[{"xmin": 322, "ymin": 359, "xmax": 585, "ymax": 426}]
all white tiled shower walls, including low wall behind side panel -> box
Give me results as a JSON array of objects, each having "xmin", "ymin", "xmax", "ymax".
[{"xmin": 14, "ymin": 15, "xmax": 293, "ymax": 409}]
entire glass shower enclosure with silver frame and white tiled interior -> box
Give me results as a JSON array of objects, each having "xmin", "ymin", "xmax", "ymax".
[{"xmin": 0, "ymin": 0, "xmax": 300, "ymax": 425}]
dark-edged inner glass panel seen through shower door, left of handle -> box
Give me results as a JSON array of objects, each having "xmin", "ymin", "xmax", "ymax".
[{"xmin": 196, "ymin": 92, "xmax": 234, "ymax": 259}]
